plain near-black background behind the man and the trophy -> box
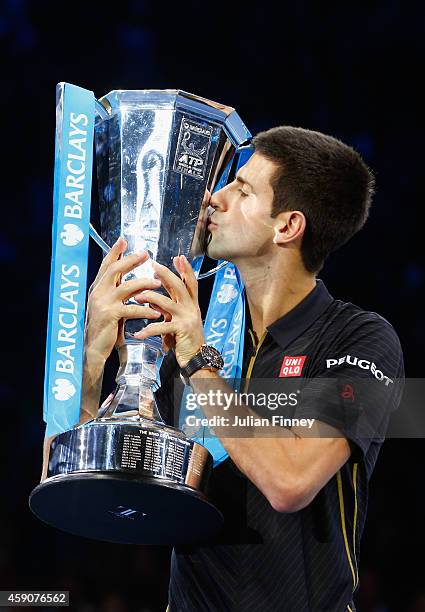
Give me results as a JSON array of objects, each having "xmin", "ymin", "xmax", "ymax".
[{"xmin": 0, "ymin": 0, "xmax": 425, "ymax": 612}]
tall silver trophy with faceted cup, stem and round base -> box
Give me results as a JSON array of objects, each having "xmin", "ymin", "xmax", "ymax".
[{"xmin": 30, "ymin": 90, "xmax": 250, "ymax": 544}]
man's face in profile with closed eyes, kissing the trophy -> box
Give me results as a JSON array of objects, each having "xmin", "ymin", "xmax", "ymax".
[{"xmin": 207, "ymin": 153, "xmax": 277, "ymax": 263}]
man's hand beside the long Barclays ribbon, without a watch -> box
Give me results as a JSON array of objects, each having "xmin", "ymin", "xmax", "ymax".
[{"xmin": 85, "ymin": 238, "xmax": 161, "ymax": 361}]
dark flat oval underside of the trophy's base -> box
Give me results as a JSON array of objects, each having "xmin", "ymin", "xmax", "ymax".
[{"xmin": 29, "ymin": 472, "xmax": 223, "ymax": 545}]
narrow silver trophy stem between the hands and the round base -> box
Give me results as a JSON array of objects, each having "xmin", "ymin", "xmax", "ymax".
[{"xmin": 101, "ymin": 341, "xmax": 163, "ymax": 423}]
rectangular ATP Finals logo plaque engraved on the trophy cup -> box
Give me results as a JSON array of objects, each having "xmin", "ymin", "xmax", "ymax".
[{"xmin": 173, "ymin": 117, "xmax": 212, "ymax": 180}]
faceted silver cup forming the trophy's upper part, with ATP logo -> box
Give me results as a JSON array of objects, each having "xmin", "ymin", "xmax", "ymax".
[{"xmin": 95, "ymin": 90, "xmax": 250, "ymax": 286}]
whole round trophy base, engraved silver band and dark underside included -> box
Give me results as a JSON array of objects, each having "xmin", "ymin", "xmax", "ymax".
[{"xmin": 29, "ymin": 416, "xmax": 223, "ymax": 544}]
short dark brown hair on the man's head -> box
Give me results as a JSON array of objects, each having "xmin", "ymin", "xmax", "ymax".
[{"xmin": 253, "ymin": 126, "xmax": 374, "ymax": 273}]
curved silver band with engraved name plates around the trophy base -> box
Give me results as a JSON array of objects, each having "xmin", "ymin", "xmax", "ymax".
[{"xmin": 47, "ymin": 418, "xmax": 211, "ymax": 492}]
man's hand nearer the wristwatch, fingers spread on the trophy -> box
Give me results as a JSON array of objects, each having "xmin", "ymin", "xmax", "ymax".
[{"xmin": 134, "ymin": 255, "xmax": 205, "ymax": 368}]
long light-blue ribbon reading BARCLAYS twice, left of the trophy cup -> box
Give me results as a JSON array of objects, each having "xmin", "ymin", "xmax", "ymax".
[{"xmin": 43, "ymin": 83, "xmax": 95, "ymax": 436}]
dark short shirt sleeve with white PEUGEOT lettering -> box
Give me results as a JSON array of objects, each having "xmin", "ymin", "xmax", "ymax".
[{"xmin": 295, "ymin": 313, "xmax": 404, "ymax": 458}]
